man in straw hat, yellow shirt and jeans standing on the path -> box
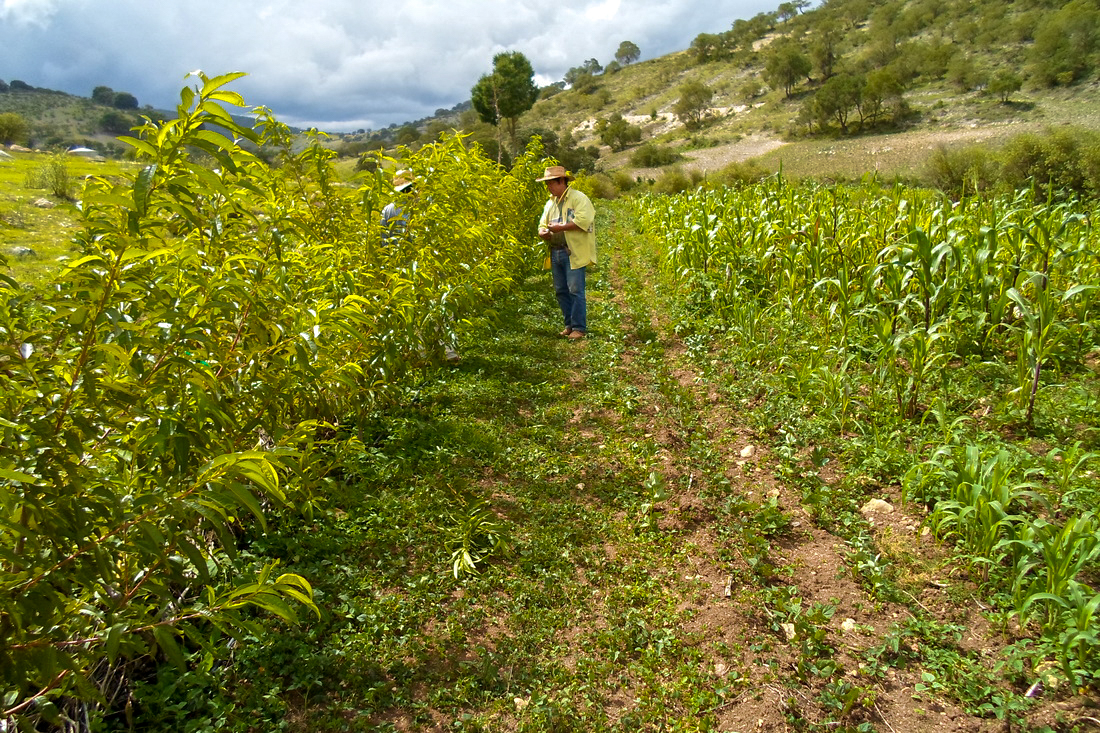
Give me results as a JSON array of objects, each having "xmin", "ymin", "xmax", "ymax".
[{"xmin": 537, "ymin": 165, "xmax": 596, "ymax": 339}]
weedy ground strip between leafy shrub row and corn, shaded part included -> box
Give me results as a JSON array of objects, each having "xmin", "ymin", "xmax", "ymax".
[{"xmin": 290, "ymin": 205, "xmax": 1088, "ymax": 733}]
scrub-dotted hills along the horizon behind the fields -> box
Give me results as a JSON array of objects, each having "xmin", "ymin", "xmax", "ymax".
[{"xmin": 0, "ymin": 0, "xmax": 1100, "ymax": 183}]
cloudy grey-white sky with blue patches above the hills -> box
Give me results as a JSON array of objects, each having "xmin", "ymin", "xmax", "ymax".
[{"xmin": 0, "ymin": 0, "xmax": 780, "ymax": 132}]
